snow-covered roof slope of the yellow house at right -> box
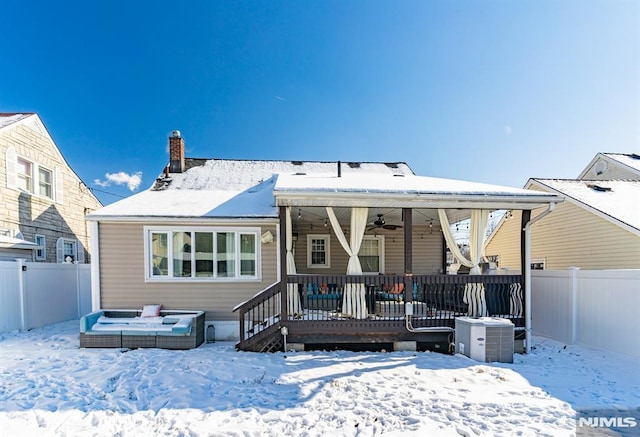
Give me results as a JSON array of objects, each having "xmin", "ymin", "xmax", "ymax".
[{"xmin": 533, "ymin": 179, "xmax": 640, "ymax": 230}]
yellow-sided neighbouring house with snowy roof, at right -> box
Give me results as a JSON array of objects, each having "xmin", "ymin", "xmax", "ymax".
[{"xmin": 485, "ymin": 153, "xmax": 640, "ymax": 271}]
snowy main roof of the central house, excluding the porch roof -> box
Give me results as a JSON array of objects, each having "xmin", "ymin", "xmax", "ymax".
[{"xmin": 87, "ymin": 158, "xmax": 413, "ymax": 220}]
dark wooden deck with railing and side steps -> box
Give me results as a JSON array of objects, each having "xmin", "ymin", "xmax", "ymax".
[{"xmin": 236, "ymin": 275, "xmax": 524, "ymax": 351}]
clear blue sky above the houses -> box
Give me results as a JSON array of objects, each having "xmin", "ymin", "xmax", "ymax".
[{"xmin": 0, "ymin": 0, "xmax": 640, "ymax": 204}]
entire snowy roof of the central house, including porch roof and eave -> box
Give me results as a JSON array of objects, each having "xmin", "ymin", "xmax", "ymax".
[{"xmin": 87, "ymin": 155, "xmax": 562, "ymax": 221}]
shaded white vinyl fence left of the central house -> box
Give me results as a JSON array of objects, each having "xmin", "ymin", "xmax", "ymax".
[{"xmin": 0, "ymin": 260, "xmax": 91, "ymax": 333}]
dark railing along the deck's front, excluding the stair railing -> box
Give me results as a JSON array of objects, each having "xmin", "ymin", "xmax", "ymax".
[{"xmin": 287, "ymin": 275, "xmax": 524, "ymax": 327}]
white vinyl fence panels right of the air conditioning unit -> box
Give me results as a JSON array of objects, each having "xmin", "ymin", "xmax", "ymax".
[{"xmin": 531, "ymin": 268, "xmax": 640, "ymax": 357}]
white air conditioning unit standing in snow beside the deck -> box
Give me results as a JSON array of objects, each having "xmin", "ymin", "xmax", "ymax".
[{"xmin": 455, "ymin": 317, "xmax": 514, "ymax": 363}]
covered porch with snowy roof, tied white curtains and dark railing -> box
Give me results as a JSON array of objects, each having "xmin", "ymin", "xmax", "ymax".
[{"xmin": 234, "ymin": 169, "xmax": 562, "ymax": 352}]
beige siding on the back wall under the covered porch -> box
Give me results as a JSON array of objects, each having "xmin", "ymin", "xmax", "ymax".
[{"xmin": 295, "ymin": 225, "xmax": 443, "ymax": 275}]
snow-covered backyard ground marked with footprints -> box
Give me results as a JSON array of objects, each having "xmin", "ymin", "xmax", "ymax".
[{"xmin": 0, "ymin": 320, "xmax": 640, "ymax": 436}]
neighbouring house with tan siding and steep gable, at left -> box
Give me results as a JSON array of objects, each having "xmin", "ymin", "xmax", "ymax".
[{"xmin": 0, "ymin": 113, "xmax": 102, "ymax": 263}]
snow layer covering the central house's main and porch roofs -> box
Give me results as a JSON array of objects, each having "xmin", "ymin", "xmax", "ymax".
[{"xmin": 87, "ymin": 160, "xmax": 557, "ymax": 220}]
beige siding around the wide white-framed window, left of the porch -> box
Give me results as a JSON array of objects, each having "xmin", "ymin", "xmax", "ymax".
[{"xmin": 99, "ymin": 223, "xmax": 278, "ymax": 320}]
